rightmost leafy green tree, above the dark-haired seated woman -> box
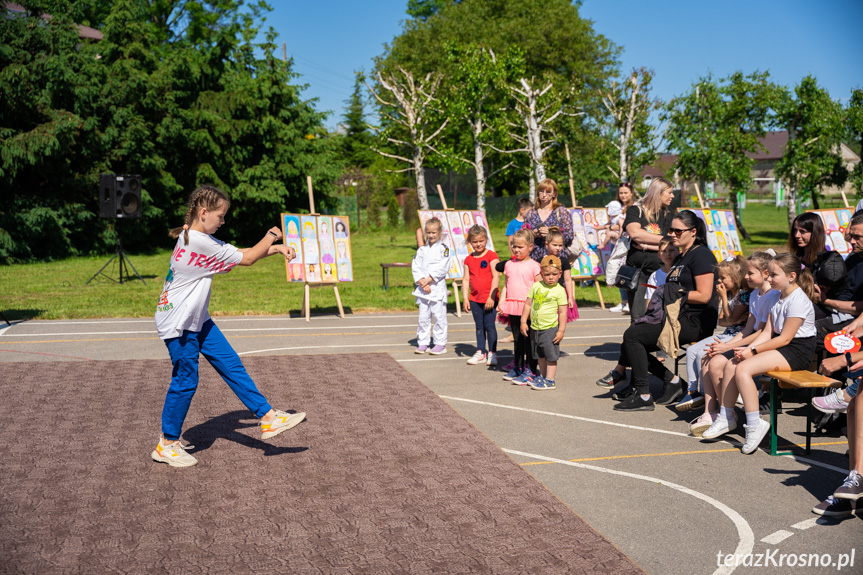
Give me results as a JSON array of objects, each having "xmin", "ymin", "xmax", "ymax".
[{"xmin": 776, "ymin": 75, "xmax": 848, "ymax": 222}]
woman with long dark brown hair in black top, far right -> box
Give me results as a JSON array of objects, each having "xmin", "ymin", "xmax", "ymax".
[{"xmin": 788, "ymin": 212, "xmax": 851, "ymax": 322}]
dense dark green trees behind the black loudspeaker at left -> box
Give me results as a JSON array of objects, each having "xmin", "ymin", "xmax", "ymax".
[{"xmin": 0, "ymin": 0, "xmax": 340, "ymax": 261}]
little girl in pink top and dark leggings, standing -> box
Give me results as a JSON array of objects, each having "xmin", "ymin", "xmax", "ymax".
[{"xmin": 497, "ymin": 229, "xmax": 540, "ymax": 381}]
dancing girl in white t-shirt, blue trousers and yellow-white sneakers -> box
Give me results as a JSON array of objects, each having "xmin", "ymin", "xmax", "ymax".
[{"xmin": 151, "ymin": 186, "xmax": 306, "ymax": 467}]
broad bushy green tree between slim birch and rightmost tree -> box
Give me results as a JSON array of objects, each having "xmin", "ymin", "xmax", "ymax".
[{"xmin": 664, "ymin": 72, "xmax": 777, "ymax": 240}]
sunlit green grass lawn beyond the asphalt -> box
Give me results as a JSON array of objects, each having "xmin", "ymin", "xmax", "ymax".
[{"xmin": 0, "ymin": 204, "xmax": 788, "ymax": 325}]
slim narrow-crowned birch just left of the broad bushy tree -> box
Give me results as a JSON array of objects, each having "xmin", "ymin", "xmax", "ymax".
[{"xmin": 599, "ymin": 68, "xmax": 660, "ymax": 182}]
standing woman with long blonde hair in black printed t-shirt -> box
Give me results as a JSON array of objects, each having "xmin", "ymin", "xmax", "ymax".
[{"xmin": 623, "ymin": 178, "xmax": 674, "ymax": 321}]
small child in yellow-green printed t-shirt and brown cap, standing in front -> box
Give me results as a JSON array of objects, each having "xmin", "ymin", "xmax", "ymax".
[{"xmin": 521, "ymin": 256, "xmax": 567, "ymax": 390}]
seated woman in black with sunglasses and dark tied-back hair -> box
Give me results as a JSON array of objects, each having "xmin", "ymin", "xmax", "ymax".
[{"xmin": 614, "ymin": 210, "xmax": 719, "ymax": 411}]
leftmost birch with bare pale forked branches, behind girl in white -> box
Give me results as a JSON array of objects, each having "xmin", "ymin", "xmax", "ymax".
[{"xmin": 366, "ymin": 66, "xmax": 449, "ymax": 210}]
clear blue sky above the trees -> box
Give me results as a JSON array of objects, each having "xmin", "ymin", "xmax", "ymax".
[{"xmin": 266, "ymin": 0, "xmax": 863, "ymax": 129}]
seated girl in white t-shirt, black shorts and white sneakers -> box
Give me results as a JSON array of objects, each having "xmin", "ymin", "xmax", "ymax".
[{"xmin": 702, "ymin": 253, "xmax": 815, "ymax": 454}]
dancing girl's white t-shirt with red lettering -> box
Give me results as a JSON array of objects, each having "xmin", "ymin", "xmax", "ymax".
[{"xmin": 156, "ymin": 230, "xmax": 243, "ymax": 339}]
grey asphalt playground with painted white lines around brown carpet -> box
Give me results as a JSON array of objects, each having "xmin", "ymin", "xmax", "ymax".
[{"xmin": 0, "ymin": 308, "xmax": 863, "ymax": 575}]
